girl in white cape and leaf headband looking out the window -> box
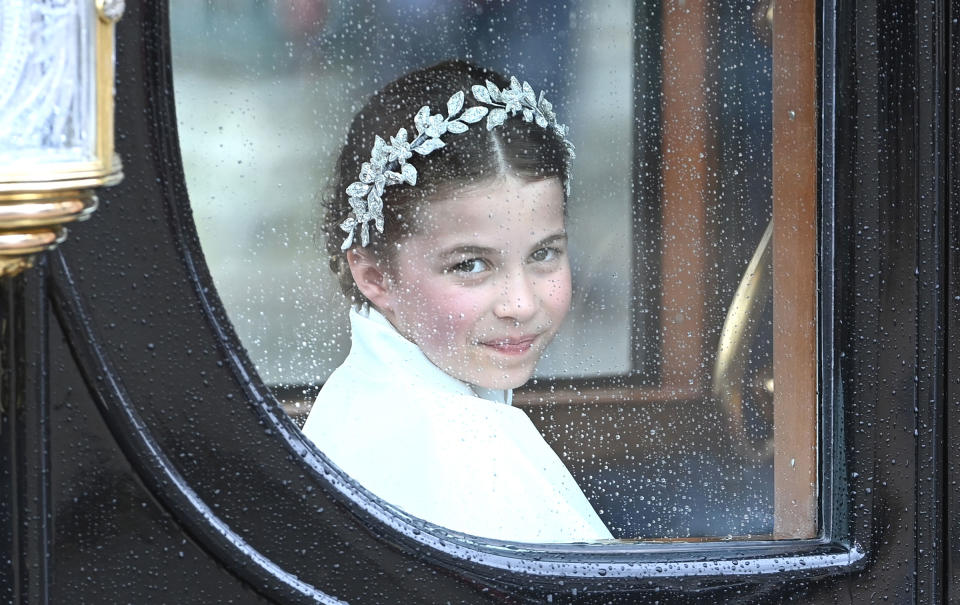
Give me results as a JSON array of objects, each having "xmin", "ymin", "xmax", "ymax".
[{"xmin": 303, "ymin": 62, "xmax": 612, "ymax": 542}]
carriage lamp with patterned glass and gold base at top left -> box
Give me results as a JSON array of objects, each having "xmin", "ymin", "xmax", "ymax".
[{"xmin": 0, "ymin": 0, "xmax": 124, "ymax": 277}]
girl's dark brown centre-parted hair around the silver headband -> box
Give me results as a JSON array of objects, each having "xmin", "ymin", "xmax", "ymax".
[{"xmin": 322, "ymin": 61, "xmax": 569, "ymax": 303}]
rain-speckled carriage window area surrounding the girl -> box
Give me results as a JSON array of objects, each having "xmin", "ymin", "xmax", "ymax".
[{"xmin": 171, "ymin": 0, "xmax": 818, "ymax": 540}]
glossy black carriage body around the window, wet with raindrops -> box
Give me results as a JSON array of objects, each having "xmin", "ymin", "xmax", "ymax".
[{"xmin": 0, "ymin": 0, "xmax": 960, "ymax": 603}]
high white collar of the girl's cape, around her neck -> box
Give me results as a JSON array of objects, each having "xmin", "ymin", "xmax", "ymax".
[{"xmin": 347, "ymin": 305, "xmax": 513, "ymax": 405}]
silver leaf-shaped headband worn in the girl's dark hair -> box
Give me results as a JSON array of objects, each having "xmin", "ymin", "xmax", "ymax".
[{"xmin": 340, "ymin": 77, "xmax": 574, "ymax": 250}]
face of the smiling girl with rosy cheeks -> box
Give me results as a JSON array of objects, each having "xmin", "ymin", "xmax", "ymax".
[{"xmin": 378, "ymin": 177, "xmax": 570, "ymax": 389}]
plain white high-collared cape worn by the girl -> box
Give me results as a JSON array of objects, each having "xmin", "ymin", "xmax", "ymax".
[{"xmin": 303, "ymin": 309, "xmax": 612, "ymax": 542}]
